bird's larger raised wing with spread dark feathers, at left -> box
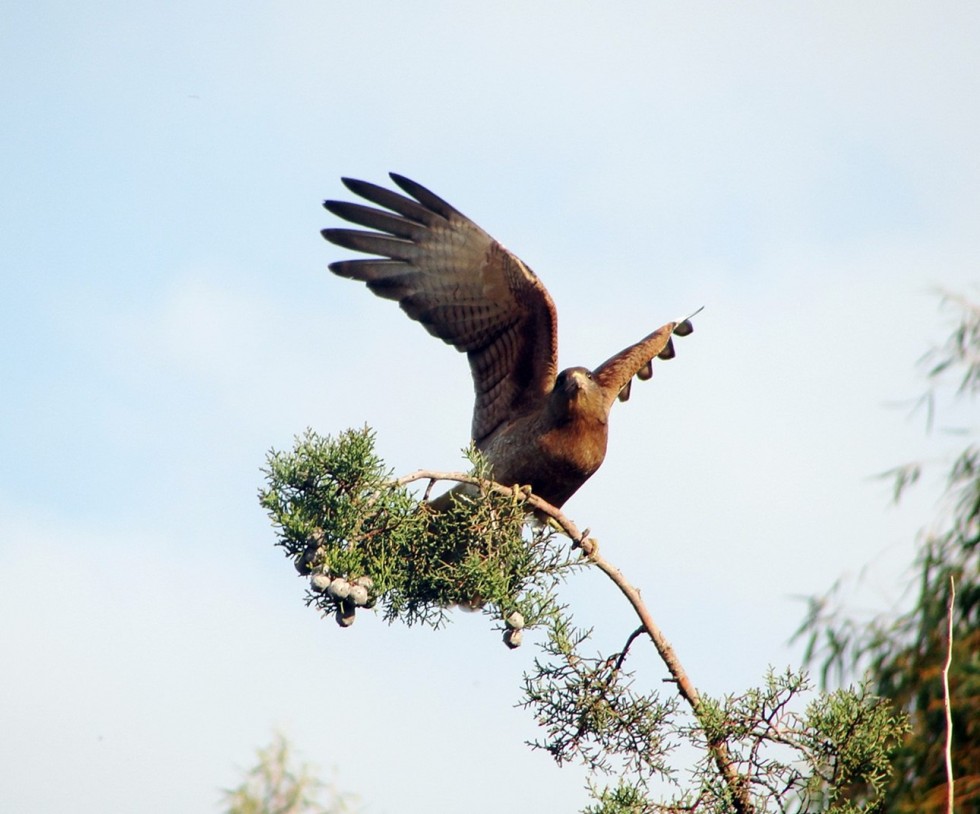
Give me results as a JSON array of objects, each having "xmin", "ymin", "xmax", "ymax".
[{"xmin": 322, "ymin": 173, "xmax": 558, "ymax": 446}]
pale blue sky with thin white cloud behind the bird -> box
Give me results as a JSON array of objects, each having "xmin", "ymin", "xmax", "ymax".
[{"xmin": 0, "ymin": 6, "xmax": 980, "ymax": 814}]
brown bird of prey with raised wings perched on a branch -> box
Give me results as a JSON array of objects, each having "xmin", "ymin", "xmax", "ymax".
[{"xmin": 322, "ymin": 173, "xmax": 692, "ymax": 508}]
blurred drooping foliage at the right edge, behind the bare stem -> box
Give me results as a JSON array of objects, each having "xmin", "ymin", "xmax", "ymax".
[{"xmin": 796, "ymin": 293, "xmax": 980, "ymax": 814}]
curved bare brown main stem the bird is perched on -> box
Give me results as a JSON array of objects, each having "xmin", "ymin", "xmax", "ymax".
[{"xmin": 393, "ymin": 469, "xmax": 755, "ymax": 814}]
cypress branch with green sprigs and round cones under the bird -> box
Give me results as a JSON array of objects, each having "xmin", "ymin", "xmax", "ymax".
[{"xmin": 260, "ymin": 428, "xmax": 903, "ymax": 814}]
